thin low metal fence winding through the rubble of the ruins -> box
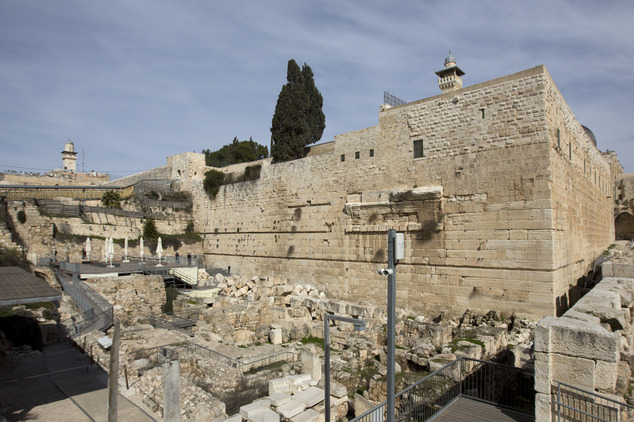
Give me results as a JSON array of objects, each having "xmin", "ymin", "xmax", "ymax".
[{"xmin": 130, "ymin": 341, "xmax": 295, "ymax": 373}]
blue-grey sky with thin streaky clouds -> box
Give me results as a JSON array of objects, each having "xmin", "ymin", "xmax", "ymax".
[{"xmin": 0, "ymin": 0, "xmax": 634, "ymax": 179}]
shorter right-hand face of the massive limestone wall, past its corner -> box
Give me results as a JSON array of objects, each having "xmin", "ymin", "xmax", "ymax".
[{"xmin": 546, "ymin": 71, "xmax": 614, "ymax": 314}]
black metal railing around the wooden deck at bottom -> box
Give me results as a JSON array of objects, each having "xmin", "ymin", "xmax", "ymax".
[{"xmin": 351, "ymin": 357, "xmax": 535, "ymax": 422}]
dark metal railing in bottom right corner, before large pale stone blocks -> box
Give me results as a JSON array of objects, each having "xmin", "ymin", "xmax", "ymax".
[{"xmin": 551, "ymin": 381, "xmax": 634, "ymax": 422}]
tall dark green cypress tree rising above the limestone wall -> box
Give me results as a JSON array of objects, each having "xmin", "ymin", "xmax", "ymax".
[{"xmin": 271, "ymin": 59, "xmax": 326, "ymax": 162}]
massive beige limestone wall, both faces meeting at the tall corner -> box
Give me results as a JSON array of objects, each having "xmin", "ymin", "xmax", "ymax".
[{"xmin": 188, "ymin": 66, "xmax": 613, "ymax": 316}]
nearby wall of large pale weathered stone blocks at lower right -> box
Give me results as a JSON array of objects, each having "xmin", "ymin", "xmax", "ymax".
[{"xmin": 535, "ymin": 277, "xmax": 634, "ymax": 422}]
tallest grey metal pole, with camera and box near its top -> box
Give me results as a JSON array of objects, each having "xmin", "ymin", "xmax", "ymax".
[{"xmin": 387, "ymin": 229, "xmax": 396, "ymax": 422}]
